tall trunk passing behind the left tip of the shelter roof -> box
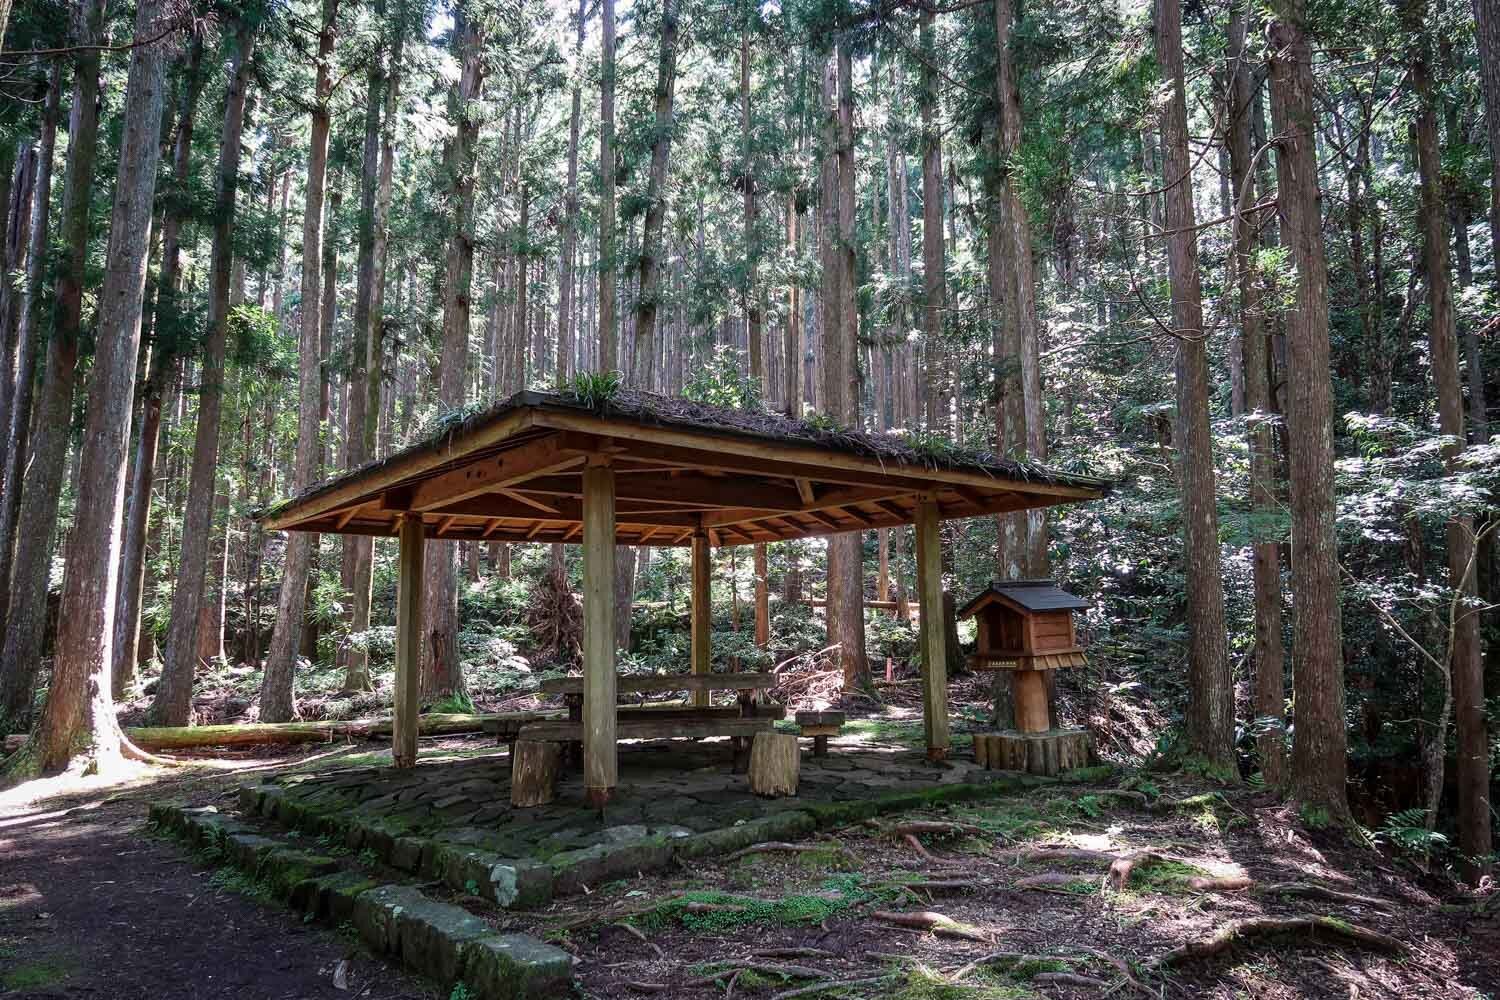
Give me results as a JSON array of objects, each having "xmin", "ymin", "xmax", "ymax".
[{"xmin": 261, "ymin": 0, "xmax": 339, "ymax": 723}]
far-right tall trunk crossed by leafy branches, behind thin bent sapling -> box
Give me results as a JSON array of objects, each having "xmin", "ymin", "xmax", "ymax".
[{"xmin": 1403, "ymin": 0, "xmax": 1491, "ymax": 882}]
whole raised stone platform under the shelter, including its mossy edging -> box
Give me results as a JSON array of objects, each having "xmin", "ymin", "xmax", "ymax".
[{"xmin": 237, "ymin": 731, "xmax": 1056, "ymax": 909}]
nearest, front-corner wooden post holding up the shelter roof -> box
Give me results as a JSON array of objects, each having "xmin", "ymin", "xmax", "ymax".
[{"xmin": 584, "ymin": 457, "xmax": 620, "ymax": 808}]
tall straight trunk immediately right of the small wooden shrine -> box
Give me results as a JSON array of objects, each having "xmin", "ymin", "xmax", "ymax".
[{"xmin": 1157, "ymin": 0, "xmax": 1235, "ymax": 774}]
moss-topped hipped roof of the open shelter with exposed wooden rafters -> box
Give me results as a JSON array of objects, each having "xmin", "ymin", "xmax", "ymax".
[{"xmin": 263, "ymin": 391, "xmax": 1109, "ymax": 544}]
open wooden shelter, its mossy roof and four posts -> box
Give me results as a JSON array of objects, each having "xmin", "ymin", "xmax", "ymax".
[{"xmin": 261, "ymin": 391, "xmax": 1107, "ymax": 802}]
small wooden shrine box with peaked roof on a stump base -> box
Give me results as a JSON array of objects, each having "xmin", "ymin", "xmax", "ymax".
[{"xmin": 959, "ymin": 580, "xmax": 1089, "ymax": 775}]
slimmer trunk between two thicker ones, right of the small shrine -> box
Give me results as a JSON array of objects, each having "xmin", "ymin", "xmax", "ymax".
[{"xmin": 1226, "ymin": 3, "xmax": 1287, "ymax": 789}]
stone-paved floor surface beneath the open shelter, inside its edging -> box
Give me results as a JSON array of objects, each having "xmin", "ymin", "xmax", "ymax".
[{"xmin": 261, "ymin": 736, "xmax": 998, "ymax": 858}]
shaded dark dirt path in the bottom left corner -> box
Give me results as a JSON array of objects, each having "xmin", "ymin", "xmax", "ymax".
[{"xmin": 0, "ymin": 779, "xmax": 435, "ymax": 1000}]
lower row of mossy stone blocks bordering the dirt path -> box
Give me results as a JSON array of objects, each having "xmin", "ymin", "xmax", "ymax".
[{"xmin": 150, "ymin": 804, "xmax": 573, "ymax": 1000}]
